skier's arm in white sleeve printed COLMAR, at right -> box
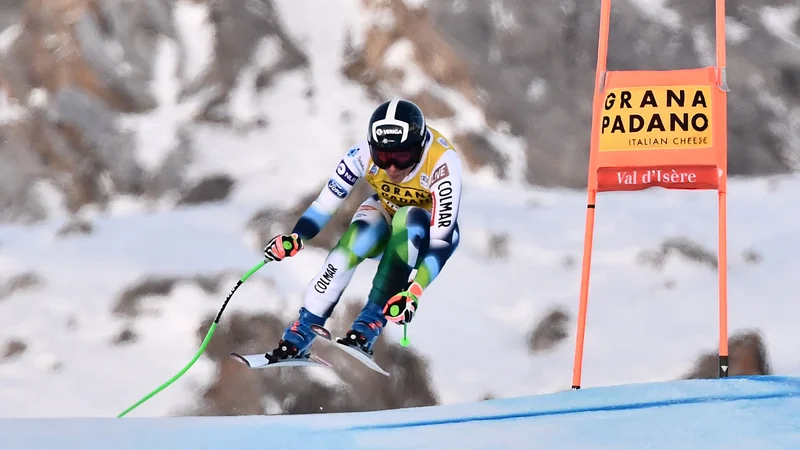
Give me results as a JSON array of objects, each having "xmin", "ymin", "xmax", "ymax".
[{"xmin": 430, "ymin": 150, "xmax": 461, "ymax": 249}]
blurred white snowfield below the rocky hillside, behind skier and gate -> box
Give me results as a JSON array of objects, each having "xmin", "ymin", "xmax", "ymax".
[{"xmin": 0, "ymin": 167, "xmax": 800, "ymax": 417}]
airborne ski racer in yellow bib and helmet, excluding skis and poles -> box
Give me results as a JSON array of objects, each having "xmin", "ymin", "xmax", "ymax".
[{"xmin": 264, "ymin": 99, "xmax": 461, "ymax": 362}]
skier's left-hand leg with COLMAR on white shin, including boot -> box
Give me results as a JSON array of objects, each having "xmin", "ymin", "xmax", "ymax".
[{"xmin": 273, "ymin": 196, "xmax": 389, "ymax": 358}]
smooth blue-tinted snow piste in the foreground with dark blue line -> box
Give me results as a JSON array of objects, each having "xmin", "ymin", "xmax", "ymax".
[{"xmin": 0, "ymin": 377, "xmax": 800, "ymax": 450}]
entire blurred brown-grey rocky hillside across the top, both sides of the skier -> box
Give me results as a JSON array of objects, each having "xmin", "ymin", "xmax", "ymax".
[{"xmin": 0, "ymin": 0, "xmax": 800, "ymax": 225}]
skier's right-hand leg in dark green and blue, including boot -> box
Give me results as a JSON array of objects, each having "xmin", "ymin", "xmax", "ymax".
[{"xmin": 346, "ymin": 206, "xmax": 430, "ymax": 353}]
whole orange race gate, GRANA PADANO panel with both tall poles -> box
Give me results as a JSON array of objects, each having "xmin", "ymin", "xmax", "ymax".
[{"xmin": 572, "ymin": 0, "xmax": 729, "ymax": 389}]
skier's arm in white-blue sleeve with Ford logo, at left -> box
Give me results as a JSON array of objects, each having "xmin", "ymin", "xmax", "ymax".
[{"xmin": 292, "ymin": 145, "xmax": 365, "ymax": 241}]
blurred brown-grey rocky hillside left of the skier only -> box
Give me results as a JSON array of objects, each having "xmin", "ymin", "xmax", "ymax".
[{"xmin": 0, "ymin": 0, "xmax": 305, "ymax": 224}]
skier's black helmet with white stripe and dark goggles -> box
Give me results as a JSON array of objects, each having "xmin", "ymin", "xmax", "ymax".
[{"xmin": 367, "ymin": 99, "xmax": 428, "ymax": 170}]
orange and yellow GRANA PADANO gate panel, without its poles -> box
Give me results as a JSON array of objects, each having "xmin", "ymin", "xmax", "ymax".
[{"xmin": 589, "ymin": 67, "xmax": 727, "ymax": 192}]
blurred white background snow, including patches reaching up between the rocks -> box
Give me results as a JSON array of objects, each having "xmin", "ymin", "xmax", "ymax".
[{"xmin": 0, "ymin": 0, "xmax": 800, "ymax": 417}]
